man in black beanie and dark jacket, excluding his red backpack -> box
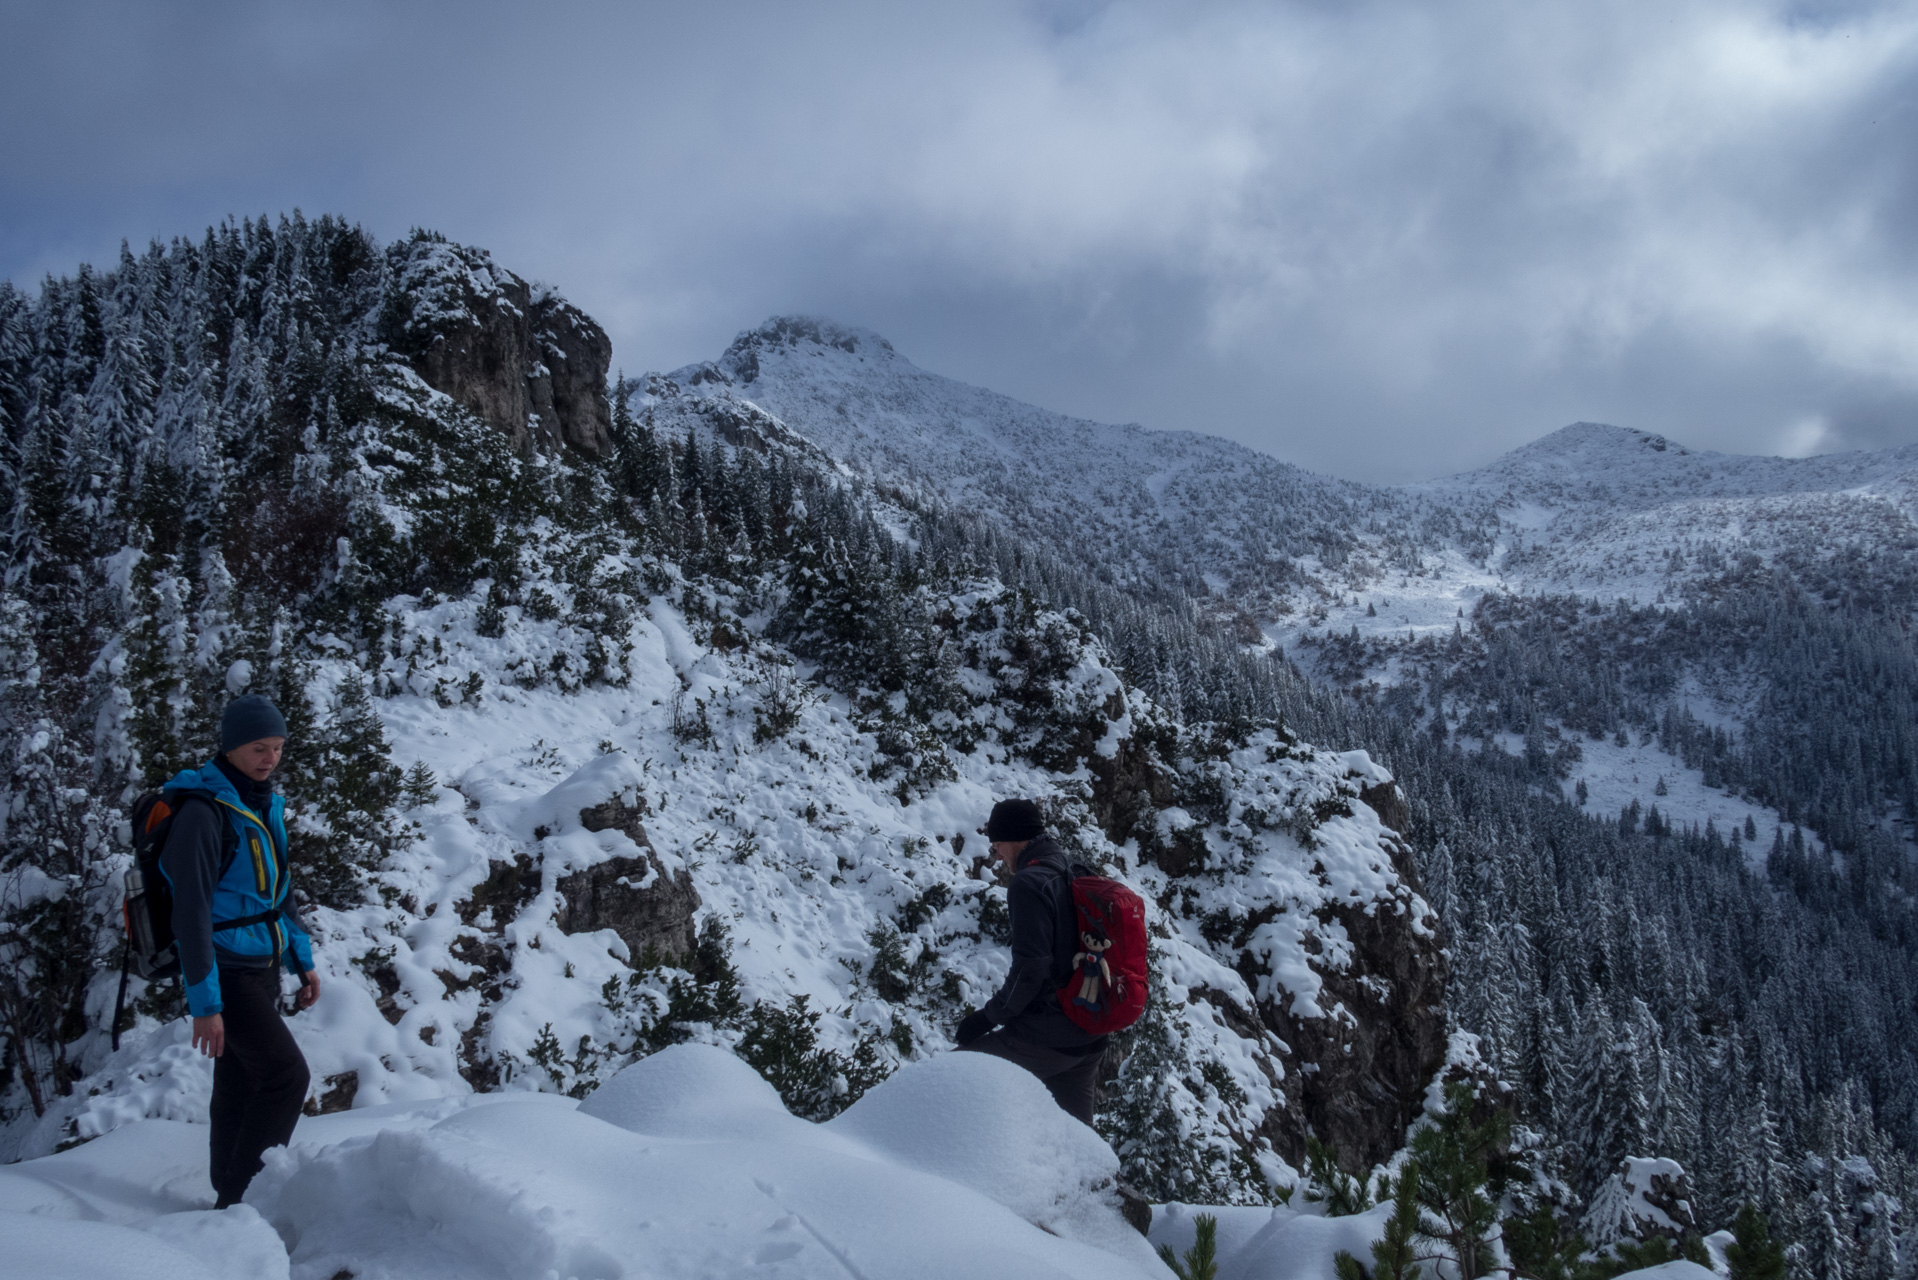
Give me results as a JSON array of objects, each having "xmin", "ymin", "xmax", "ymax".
[{"xmin": 955, "ymin": 800, "xmax": 1107, "ymax": 1125}]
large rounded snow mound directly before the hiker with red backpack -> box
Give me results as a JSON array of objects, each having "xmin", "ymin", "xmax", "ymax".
[{"xmin": 825, "ymin": 1054, "xmax": 1155, "ymax": 1267}]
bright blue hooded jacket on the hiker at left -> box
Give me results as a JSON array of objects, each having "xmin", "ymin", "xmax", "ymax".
[{"xmin": 159, "ymin": 760, "xmax": 313, "ymax": 1017}]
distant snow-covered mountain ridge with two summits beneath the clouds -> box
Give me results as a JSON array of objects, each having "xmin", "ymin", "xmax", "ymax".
[{"xmin": 640, "ymin": 317, "xmax": 1918, "ymax": 621}]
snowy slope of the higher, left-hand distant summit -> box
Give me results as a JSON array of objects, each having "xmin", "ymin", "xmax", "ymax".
[{"xmin": 671, "ymin": 317, "xmax": 1490, "ymax": 616}]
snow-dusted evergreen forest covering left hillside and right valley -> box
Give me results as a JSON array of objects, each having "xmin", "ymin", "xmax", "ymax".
[{"xmin": 0, "ymin": 215, "xmax": 1918, "ymax": 1280}]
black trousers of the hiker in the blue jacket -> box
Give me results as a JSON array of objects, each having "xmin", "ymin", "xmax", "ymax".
[{"xmin": 207, "ymin": 965, "xmax": 307, "ymax": 1207}]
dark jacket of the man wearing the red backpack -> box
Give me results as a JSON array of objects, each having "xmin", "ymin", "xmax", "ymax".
[{"xmin": 984, "ymin": 835, "xmax": 1105, "ymax": 1050}]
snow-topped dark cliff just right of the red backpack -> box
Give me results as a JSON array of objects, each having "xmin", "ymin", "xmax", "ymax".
[{"xmin": 1089, "ymin": 721, "xmax": 1448, "ymax": 1171}]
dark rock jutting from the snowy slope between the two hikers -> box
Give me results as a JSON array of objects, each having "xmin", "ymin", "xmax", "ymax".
[{"xmin": 558, "ymin": 798, "xmax": 700, "ymax": 963}]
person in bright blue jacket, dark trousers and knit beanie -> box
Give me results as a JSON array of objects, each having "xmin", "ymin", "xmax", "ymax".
[{"xmin": 159, "ymin": 693, "xmax": 320, "ymax": 1209}]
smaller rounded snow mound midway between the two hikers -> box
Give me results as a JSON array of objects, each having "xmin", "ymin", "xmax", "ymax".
[{"xmin": 579, "ymin": 1044, "xmax": 815, "ymax": 1140}]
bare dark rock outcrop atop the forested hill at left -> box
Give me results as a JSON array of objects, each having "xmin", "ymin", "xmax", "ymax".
[{"xmin": 380, "ymin": 232, "xmax": 612, "ymax": 455}]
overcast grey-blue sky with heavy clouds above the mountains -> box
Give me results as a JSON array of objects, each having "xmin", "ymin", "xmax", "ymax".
[{"xmin": 0, "ymin": 0, "xmax": 1918, "ymax": 480}]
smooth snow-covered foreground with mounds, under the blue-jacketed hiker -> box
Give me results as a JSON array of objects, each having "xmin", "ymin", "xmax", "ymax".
[{"xmin": 0, "ymin": 1044, "xmax": 1162, "ymax": 1280}]
